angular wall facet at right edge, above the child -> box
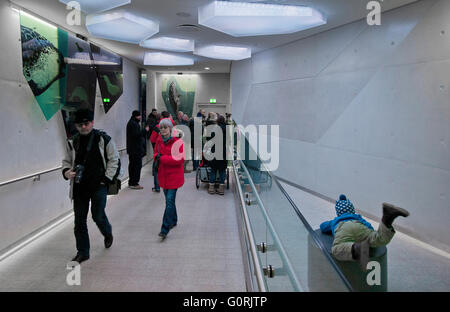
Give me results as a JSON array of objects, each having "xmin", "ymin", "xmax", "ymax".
[{"xmin": 319, "ymin": 61, "xmax": 450, "ymax": 170}]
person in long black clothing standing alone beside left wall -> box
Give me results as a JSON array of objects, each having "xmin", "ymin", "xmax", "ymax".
[{"xmin": 127, "ymin": 110, "xmax": 149, "ymax": 190}]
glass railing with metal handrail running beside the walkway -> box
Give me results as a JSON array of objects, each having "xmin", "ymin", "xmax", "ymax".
[{"xmin": 233, "ymin": 125, "xmax": 353, "ymax": 291}]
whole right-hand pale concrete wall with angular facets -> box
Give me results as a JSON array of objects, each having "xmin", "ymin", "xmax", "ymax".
[{"xmin": 231, "ymin": 0, "xmax": 450, "ymax": 250}]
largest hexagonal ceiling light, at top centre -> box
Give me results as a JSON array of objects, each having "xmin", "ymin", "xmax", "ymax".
[{"xmin": 198, "ymin": 1, "xmax": 326, "ymax": 37}]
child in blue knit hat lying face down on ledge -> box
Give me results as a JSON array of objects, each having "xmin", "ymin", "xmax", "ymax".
[{"xmin": 320, "ymin": 195, "xmax": 409, "ymax": 271}]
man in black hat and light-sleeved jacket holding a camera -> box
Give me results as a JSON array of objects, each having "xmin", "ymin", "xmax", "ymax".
[{"xmin": 62, "ymin": 109, "xmax": 121, "ymax": 263}]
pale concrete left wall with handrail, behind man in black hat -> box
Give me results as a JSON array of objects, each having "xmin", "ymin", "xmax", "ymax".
[{"xmin": 0, "ymin": 0, "xmax": 139, "ymax": 250}]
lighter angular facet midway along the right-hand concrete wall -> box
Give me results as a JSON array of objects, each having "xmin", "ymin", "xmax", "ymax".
[{"xmin": 243, "ymin": 70, "xmax": 374, "ymax": 142}]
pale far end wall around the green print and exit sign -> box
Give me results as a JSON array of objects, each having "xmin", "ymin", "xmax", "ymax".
[{"xmin": 156, "ymin": 73, "xmax": 231, "ymax": 115}]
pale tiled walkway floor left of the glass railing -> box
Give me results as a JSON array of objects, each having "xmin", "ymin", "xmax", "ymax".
[{"xmin": 0, "ymin": 166, "xmax": 246, "ymax": 292}]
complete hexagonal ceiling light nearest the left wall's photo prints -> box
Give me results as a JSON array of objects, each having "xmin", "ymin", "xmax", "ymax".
[{"xmin": 86, "ymin": 12, "xmax": 159, "ymax": 44}]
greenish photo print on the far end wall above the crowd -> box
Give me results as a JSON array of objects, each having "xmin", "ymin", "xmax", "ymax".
[{"xmin": 162, "ymin": 75, "xmax": 197, "ymax": 118}]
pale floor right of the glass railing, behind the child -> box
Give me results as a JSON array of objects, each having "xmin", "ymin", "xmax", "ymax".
[{"xmin": 281, "ymin": 183, "xmax": 450, "ymax": 292}]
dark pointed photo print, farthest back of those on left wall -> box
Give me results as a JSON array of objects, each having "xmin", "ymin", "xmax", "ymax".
[{"xmin": 91, "ymin": 43, "xmax": 123, "ymax": 113}]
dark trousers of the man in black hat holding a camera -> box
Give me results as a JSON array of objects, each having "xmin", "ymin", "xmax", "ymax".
[{"xmin": 73, "ymin": 185, "xmax": 112, "ymax": 256}]
